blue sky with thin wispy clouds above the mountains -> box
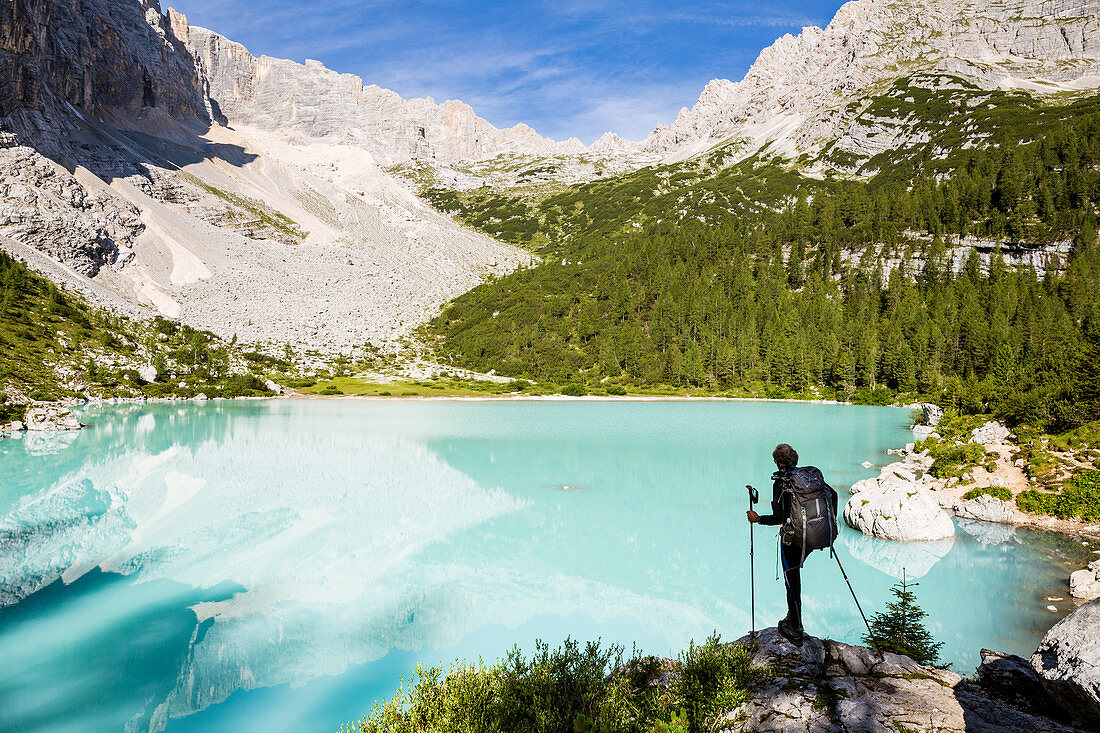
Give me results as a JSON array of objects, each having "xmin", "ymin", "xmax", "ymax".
[{"xmin": 169, "ymin": 0, "xmax": 842, "ymax": 143}]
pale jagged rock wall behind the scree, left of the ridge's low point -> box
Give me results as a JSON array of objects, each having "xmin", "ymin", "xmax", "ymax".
[{"xmin": 185, "ymin": 23, "xmax": 585, "ymax": 164}]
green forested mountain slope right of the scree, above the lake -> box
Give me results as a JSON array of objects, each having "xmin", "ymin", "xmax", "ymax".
[{"xmin": 428, "ymin": 85, "xmax": 1100, "ymax": 426}]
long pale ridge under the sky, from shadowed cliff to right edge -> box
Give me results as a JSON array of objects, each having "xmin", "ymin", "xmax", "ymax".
[{"xmin": 169, "ymin": 0, "xmax": 1100, "ymax": 182}]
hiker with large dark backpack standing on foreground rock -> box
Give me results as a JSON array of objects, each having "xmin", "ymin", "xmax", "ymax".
[{"xmin": 748, "ymin": 442, "xmax": 838, "ymax": 646}]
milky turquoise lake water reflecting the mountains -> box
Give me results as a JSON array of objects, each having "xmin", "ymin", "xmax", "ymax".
[{"xmin": 0, "ymin": 401, "xmax": 1082, "ymax": 733}]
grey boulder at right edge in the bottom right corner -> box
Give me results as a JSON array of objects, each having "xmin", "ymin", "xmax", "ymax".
[{"xmin": 1031, "ymin": 599, "xmax": 1100, "ymax": 730}]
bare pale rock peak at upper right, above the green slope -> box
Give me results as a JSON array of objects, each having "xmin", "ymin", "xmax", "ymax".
[{"xmin": 642, "ymin": 0, "xmax": 1100, "ymax": 165}]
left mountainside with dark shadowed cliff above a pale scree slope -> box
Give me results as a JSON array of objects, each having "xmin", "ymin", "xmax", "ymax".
[{"xmin": 0, "ymin": 0, "xmax": 530, "ymax": 353}]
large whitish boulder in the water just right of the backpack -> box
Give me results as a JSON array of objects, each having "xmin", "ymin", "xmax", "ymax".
[{"xmin": 844, "ymin": 463, "xmax": 955, "ymax": 541}]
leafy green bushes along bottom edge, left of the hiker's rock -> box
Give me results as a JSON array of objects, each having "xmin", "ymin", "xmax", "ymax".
[{"xmin": 349, "ymin": 636, "xmax": 766, "ymax": 733}]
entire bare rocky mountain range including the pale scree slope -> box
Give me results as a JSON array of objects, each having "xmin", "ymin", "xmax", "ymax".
[{"xmin": 0, "ymin": 0, "xmax": 1100, "ymax": 349}]
